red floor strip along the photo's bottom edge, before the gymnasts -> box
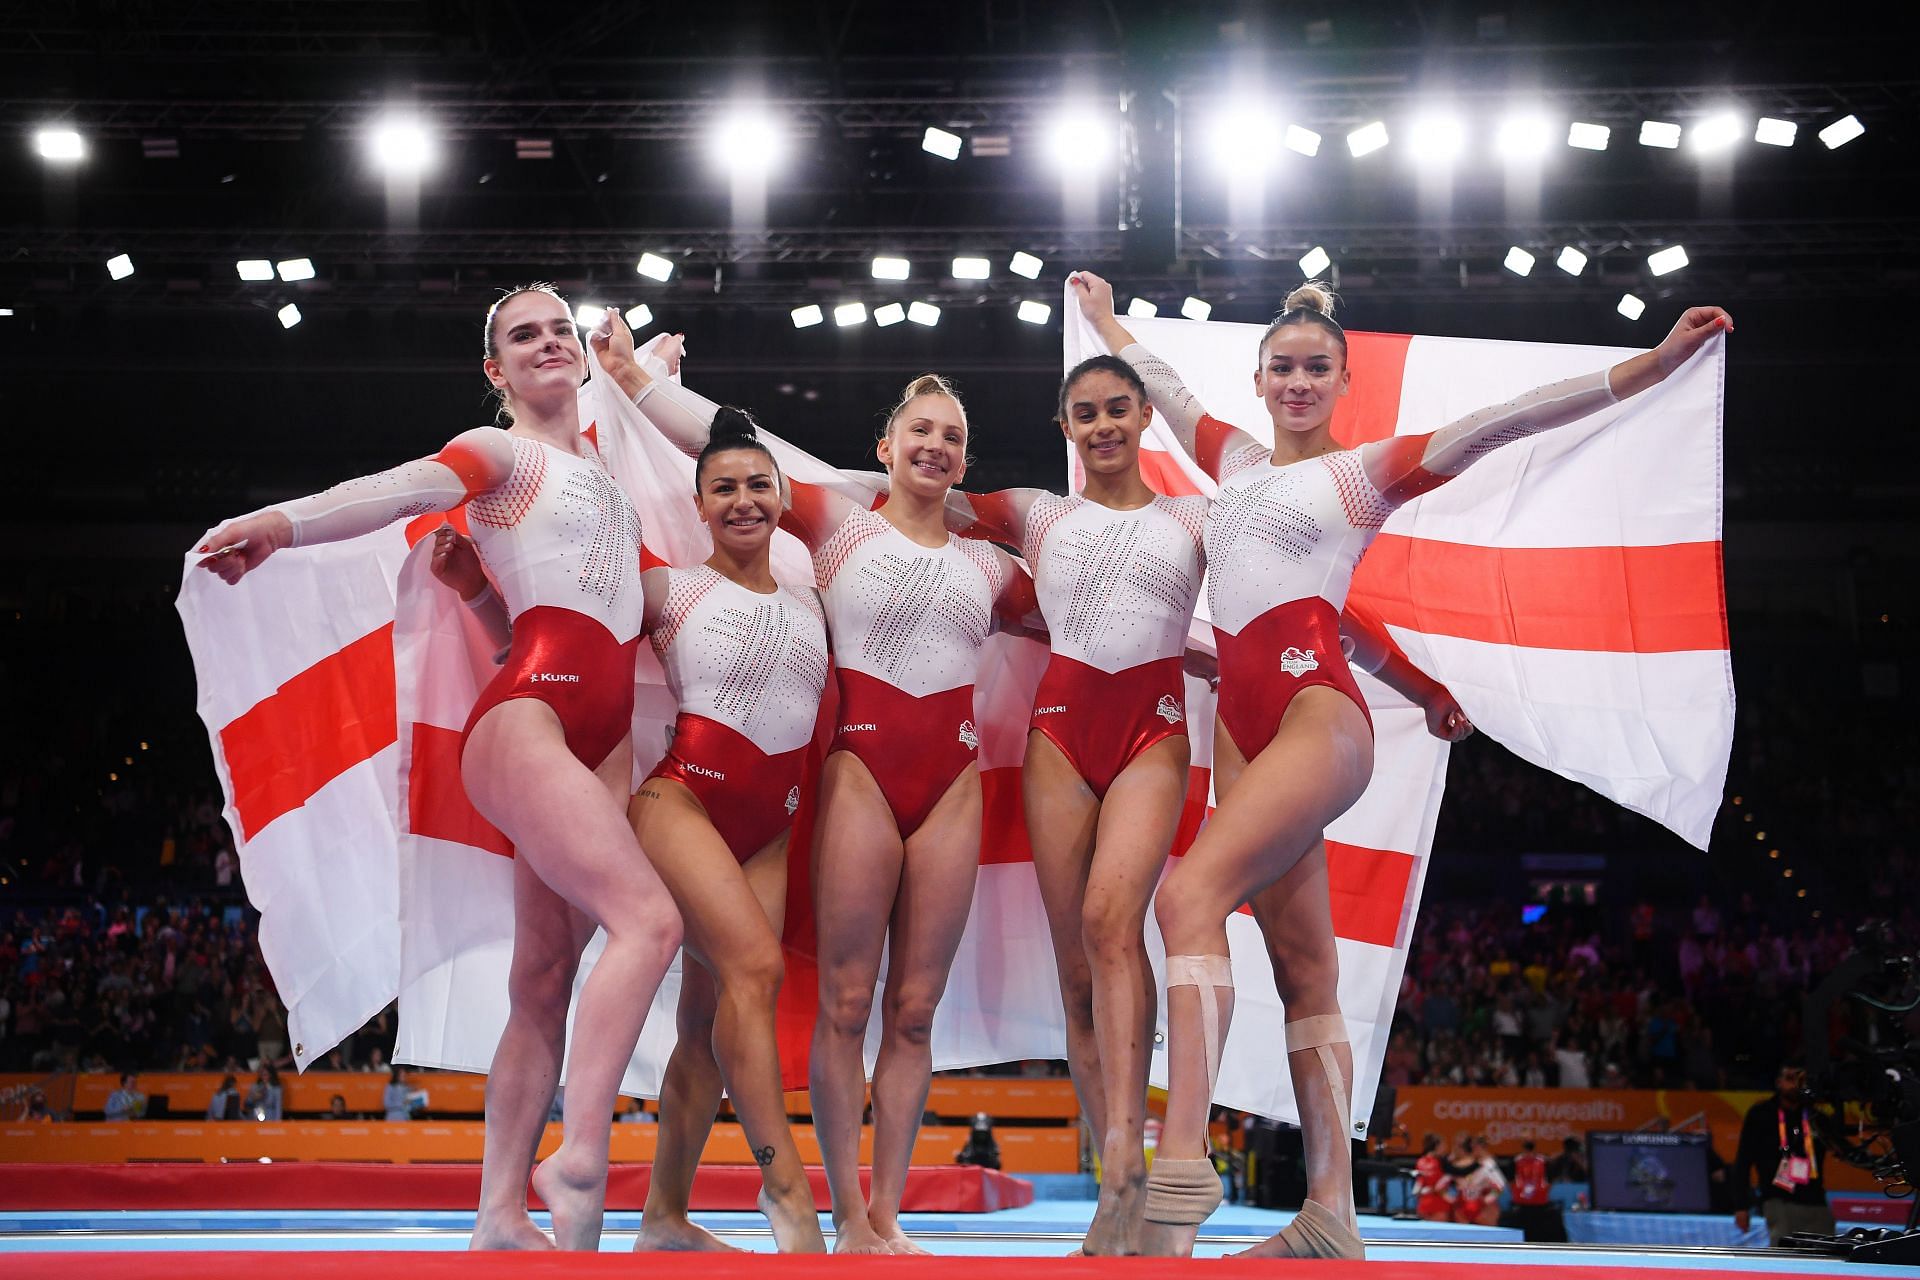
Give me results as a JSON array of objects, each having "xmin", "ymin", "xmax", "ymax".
[{"xmin": 8, "ymin": 1253, "xmax": 1850, "ymax": 1280}]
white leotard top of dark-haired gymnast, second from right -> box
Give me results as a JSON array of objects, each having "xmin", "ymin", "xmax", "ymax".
[{"xmin": 1021, "ymin": 493, "xmax": 1206, "ymax": 674}]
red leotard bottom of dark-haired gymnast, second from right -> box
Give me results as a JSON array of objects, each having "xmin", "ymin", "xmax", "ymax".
[{"xmin": 1031, "ymin": 654, "xmax": 1187, "ymax": 800}]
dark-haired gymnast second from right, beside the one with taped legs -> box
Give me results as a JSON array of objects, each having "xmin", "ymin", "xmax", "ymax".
[{"xmin": 947, "ymin": 355, "xmax": 1471, "ymax": 1255}]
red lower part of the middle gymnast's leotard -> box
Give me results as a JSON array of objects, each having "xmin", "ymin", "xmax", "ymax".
[{"xmin": 828, "ymin": 668, "xmax": 979, "ymax": 841}]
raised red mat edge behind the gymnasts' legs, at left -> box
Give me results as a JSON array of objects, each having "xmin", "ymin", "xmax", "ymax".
[{"xmin": 4, "ymin": 1163, "xmax": 1033, "ymax": 1213}]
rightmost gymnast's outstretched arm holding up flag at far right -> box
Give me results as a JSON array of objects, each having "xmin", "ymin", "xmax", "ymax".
[{"xmin": 1359, "ymin": 307, "xmax": 1734, "ymax": 507}]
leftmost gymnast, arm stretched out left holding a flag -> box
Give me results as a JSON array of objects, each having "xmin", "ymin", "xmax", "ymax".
[{"xmin": 200, "ymin": 286, "xmax": 682, "ymax": 1249}]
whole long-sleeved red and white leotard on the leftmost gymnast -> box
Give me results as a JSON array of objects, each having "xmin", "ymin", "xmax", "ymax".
[{"xmin": 278, "ymin": 428, "xmax": 645, "ymax": 768}]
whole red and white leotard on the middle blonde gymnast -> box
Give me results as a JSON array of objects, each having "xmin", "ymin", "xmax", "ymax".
[{"xmin": 639, "ymin": 380, "xmax": 1031, "ymax": 839}]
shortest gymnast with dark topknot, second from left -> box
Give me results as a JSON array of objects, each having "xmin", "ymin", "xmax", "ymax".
[{"xmin": 434, "ymin": 385, "xmax": 828, "ymax": 1253}]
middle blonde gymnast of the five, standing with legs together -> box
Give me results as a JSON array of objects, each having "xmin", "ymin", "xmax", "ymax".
[{"xmin": 610, "ymin": 358, "xmax": 1035, "ymax": 1253}]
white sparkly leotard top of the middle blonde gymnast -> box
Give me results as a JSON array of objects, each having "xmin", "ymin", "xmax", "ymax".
[{"xmin": 814, "ymin": 502, "xmax": 1006, "ymax": 699}]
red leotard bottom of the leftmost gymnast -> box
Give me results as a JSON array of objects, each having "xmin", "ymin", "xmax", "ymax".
[{"xmin": 461, "ymin": 604, "xmax": 639, "ymax": 770}]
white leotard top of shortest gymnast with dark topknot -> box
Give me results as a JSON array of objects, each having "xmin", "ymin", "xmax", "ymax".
[{"xmin": 649, "ymin": 564, "xmax": 828, "ymax": 756}]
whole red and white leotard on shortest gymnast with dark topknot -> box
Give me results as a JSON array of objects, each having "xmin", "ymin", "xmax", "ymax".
[{"xmin": 647, "ymin": 564, "xmax": 828, "ymax": 862}]
